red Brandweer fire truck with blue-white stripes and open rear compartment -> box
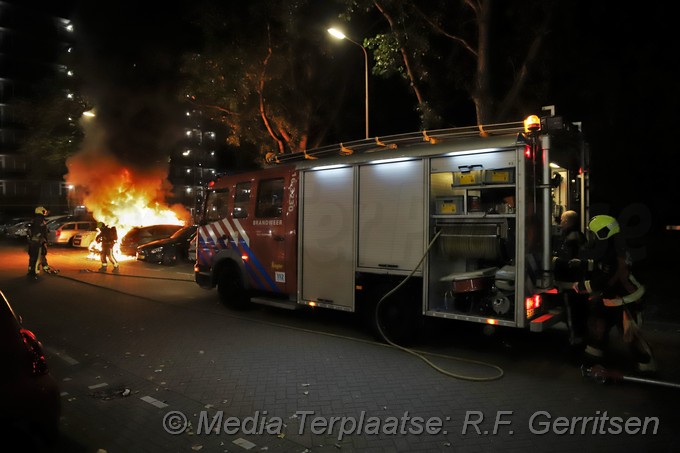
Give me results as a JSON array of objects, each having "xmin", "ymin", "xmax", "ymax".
[{"xmin": 194, "ymin": 107, "xmax": 589, "ymax": 341}]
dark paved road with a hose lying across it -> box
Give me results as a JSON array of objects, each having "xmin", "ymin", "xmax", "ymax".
[{"xmin": 0, "ymin": 242, "xmax": 680, "ymax": 453}]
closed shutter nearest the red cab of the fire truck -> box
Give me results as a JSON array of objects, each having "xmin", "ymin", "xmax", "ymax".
[{"xmin": 299, "ymin": 167, "xmax": 356, "ymax": 311}]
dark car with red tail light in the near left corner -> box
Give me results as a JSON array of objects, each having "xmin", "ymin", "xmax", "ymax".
[{"xmin": 0, "ymin": 291, "xmax": 61, "ymax": 444}]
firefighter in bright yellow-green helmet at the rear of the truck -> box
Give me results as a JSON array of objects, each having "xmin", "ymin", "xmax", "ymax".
[{"xmin": 571, "ymin": 215, "xmax": 656, "ymax": 372}]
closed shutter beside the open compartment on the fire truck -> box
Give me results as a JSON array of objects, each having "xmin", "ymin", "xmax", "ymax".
[{"xmin": 357, "ymin": 159, "xmax": 426, "ymax": 274}]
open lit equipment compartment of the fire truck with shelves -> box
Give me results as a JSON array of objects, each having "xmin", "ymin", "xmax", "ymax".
[{"xmin": 424, "ymin": 147, "xmax": 525, "ymax": 326}]
